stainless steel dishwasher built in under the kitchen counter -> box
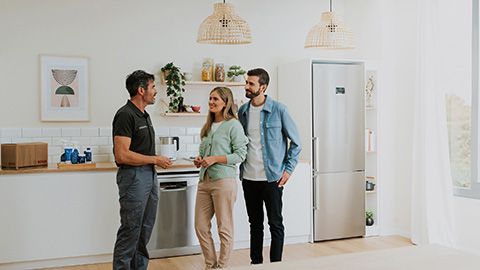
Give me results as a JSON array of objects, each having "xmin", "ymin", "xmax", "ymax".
[{"xmin": 147, "ymin": 170, "xmax": 201, "ymax": 258}]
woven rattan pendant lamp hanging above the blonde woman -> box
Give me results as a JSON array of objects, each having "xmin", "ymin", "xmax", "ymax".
[{"xmin": 197, "ymin": 0, "xmax": 252, "ymax": 45}]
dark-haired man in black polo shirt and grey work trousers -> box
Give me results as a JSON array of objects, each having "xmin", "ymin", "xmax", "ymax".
[{"xmin": 112, "ymin": 70, "xmax": 172, "ymax": 269}]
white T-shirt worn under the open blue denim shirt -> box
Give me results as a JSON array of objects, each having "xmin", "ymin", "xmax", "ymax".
[{"xmin": 243, "ymin": 104, "xmax": 267, "ymax": 181}]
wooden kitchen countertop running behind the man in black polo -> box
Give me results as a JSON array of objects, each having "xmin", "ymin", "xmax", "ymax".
[{"xmin": 0, "ymin": 159, "xmax": 196, "ymax": 175}]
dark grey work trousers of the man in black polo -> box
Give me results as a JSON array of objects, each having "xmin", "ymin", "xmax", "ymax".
[{"xmin": 113, "ymin": 165, "xmax": 158, "ymax": 270}]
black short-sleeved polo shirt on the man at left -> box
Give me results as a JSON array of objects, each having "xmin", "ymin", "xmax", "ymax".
[{"xmin": 112, "ymin": 100, "xmax": 155, "ymax": 165}]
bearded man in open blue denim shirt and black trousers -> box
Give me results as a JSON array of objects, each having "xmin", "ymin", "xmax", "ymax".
[{"xmin": 238, "ymin": 68, "xmax": 301, "ymax": 264}]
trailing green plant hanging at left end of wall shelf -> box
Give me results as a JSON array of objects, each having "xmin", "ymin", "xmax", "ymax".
[{"xmin": 162, "ymin": 63, "xmax": 185, "ymax": 112}]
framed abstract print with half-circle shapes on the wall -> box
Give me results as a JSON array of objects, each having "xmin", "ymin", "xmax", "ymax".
[{"xmin": 40, "ymin": 55, "xmax": 90, "ymax": 121}]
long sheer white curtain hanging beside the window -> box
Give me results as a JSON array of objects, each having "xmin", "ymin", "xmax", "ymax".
[{"xmin": 411, "ymin": 0, "xmax": 455, "ymax": 247}]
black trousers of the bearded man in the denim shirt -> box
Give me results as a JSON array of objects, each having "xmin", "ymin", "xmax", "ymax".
[{"xmin": 242, "ymin": 179, "xmax": 285, "ymax": 264}]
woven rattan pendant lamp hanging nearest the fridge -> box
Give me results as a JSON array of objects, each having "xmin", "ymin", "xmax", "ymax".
[{"xmin": 305, "ymin": 0, "xmax": 355, "ymax": 49}]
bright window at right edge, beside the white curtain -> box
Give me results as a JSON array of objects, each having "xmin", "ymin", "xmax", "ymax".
[{"xmin": 443, "ymin": 0, "xmax": 480, "ymax": 199}]
